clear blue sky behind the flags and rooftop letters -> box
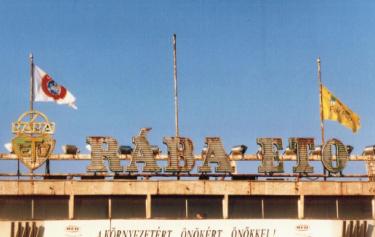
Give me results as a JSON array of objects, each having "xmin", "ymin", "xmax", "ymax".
[{"xmin": 0, "ymin": 0, "xmax": 375, "ymax": 172}]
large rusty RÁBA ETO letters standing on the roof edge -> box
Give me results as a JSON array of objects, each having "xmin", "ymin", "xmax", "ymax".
[{"xmin": 86, "ymin": 132, "xmax": 349, "ymax": 173}]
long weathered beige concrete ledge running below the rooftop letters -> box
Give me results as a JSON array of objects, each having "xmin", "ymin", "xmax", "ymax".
[{"xmin": 0, "ymin": 180, "xmax": 375, "ymax": 196}]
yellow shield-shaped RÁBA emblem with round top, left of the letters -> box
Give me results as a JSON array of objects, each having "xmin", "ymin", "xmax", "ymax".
[{"xmin": 12, "ymin": 110, "xmax": 56, "ymax": 170}]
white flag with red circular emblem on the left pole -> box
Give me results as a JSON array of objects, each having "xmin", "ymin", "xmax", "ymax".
[{"xmin": 34, "ymin": 65, "xmax": 77, "ymax": 109}]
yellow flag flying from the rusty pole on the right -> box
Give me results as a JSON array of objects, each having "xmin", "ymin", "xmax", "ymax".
[{"xmin": 322, "ymin": 86, "xmax": 361, "ymax": 132}]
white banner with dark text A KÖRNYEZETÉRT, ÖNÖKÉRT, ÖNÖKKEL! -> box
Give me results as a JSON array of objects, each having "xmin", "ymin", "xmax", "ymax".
[{"xmin": 0, "ymin": 219, "xmax": 374, "ymax": 237}]
